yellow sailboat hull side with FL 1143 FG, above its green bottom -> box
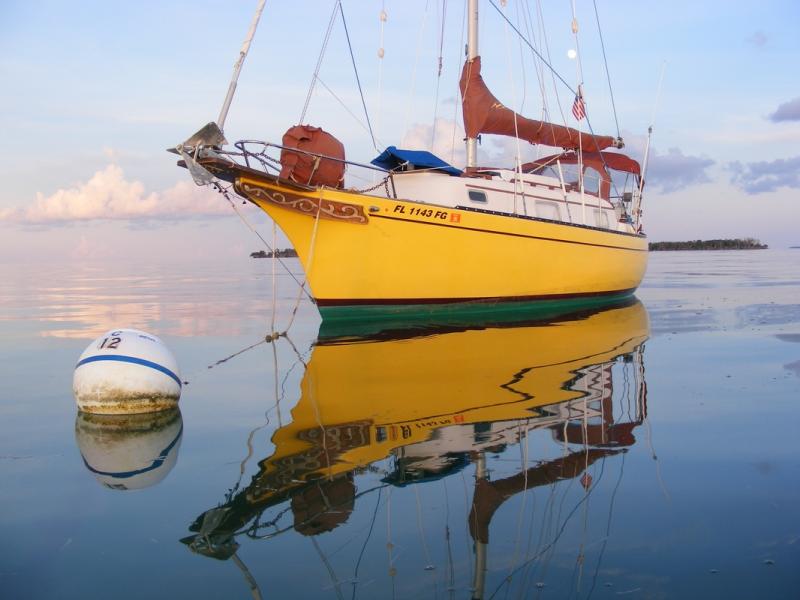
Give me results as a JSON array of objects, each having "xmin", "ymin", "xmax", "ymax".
[{"xmin": 236, "ymin": 175, "xmax": 647, "ymax": 307}]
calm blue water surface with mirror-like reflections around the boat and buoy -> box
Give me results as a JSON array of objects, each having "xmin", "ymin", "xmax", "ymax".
[{"xmin": 0, "ymin": 250, "xmax": 800, "ymax": 599}]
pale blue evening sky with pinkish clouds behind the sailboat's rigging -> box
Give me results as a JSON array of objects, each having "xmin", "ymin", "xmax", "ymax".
[{"xmin": 0, "ymin": 0, "xmax": 800, "ymax": 263}]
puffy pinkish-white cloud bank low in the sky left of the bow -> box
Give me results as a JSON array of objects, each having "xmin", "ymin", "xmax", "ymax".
[{"xmin": 0, "ymin": 164, "xmax": 230, "ymax": 224}]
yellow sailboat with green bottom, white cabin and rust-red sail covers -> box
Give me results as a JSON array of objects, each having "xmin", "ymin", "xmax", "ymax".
[{"xmin": 173, "ymin": 0, "xmax": 647, "ymax": 319}]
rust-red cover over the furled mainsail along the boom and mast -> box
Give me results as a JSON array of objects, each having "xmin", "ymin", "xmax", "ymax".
[{"xmin": 459, "ymin": 56, "xmax": 617, "ymax": 152}]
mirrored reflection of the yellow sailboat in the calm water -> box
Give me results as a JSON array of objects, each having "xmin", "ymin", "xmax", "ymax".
[{"xmin": 182, "ymin": 300, "xmax": 649, "ymax": 597}]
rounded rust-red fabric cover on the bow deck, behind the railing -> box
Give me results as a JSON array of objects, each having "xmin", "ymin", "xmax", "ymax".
[{"xmin": 279, "ymin": 125, "xmax": 345, "ymax": 188}]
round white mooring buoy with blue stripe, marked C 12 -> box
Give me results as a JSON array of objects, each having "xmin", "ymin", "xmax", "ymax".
[{"xmin": 72, "ymin": 329, "xmax": 182, "ymax": 415}]
